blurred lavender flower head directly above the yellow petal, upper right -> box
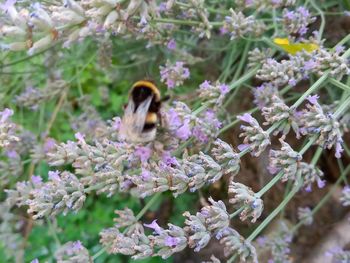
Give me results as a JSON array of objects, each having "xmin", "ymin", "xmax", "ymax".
[{"xmin": 283, "ymin": 6, "xmax": 316, "ymax": 36}]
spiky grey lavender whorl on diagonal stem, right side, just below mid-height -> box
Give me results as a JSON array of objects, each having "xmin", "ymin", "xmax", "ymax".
[{"xmin": 269, "ymin": 139, "xmax": 302, "ymax": 183}]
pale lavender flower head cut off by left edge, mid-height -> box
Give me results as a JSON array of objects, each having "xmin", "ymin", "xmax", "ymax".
[{"xmin": 0, "ymin": 108, "xmax": 19, "ymax": 147}]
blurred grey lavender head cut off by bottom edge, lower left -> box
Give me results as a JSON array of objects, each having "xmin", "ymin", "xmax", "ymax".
[{"xmin": 55, "ymin": 240, "xmax": 92, "ymax": 263}]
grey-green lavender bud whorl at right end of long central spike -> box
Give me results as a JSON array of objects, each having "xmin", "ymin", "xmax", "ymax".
[{"xmin": 211, "ymin": 138, "xmax": 240, "ymax": 176}]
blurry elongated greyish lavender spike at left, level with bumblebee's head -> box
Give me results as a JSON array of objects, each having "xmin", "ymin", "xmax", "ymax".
[{"xmin": 15, "ymin": 80, "xmax": 67, "ymax": 110}]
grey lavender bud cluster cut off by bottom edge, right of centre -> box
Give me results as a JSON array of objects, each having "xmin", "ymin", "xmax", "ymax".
[{"xmin": 217, "ymin": 227, "xmax": 258, "ymax": 263}]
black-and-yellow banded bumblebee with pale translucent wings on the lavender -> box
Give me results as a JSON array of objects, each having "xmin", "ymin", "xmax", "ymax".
[{"xmin": 120, "ymin": 80, "xmax": 163, "ymax": 142}]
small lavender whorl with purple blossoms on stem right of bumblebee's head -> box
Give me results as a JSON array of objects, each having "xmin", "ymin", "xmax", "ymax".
[{"xmin": 199, "ymin": 80, "xmax": 230, "ymax": 109}]
